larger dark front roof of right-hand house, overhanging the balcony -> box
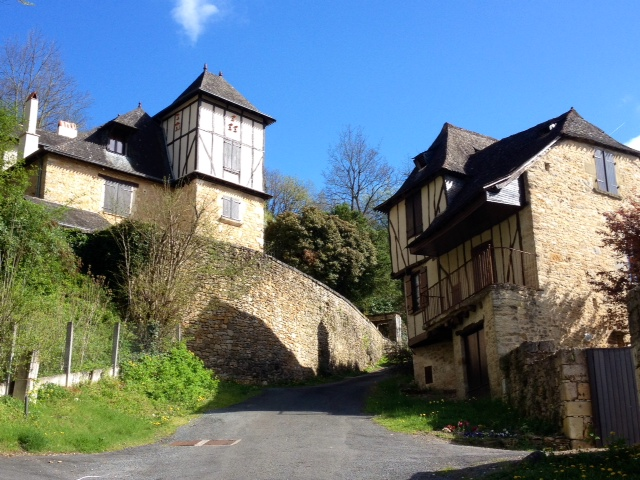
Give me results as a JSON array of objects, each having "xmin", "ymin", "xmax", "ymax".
[{"xmin": 409, "ymin": 108, "xmax": 640, "ymax": 251}]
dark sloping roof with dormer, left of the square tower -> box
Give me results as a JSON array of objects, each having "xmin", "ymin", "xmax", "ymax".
[{"xmin": 31, "ymin": 106, "xmax": 172, "ymax": 181}]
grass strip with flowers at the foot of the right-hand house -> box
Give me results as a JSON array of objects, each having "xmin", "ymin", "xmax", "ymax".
[{"xmin": 366, "ymin": 375, "xmax": 553, "ymax": 437}]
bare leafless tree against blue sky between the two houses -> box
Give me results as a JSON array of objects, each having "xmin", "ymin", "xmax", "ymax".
[{"xmin": 323, "ymin": 126, "xmax": 397, "ymax": 218}]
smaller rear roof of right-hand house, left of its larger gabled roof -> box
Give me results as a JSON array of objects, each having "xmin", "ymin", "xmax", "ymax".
[{"xmin": 376, "ymin": 123, "xmax": 496, "ymax": 212}]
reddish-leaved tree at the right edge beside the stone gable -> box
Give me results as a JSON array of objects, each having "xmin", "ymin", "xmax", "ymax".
[{"xmin": 591, "ymin": 198, "xmax": 640, "ymax": 316}]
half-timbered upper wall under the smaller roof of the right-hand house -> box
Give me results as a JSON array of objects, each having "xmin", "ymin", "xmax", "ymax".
[{"xmin": 389, "ymin": 177, "xmax": 448, "ymax": 275}]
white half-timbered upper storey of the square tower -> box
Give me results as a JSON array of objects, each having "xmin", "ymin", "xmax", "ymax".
[{"xmin": 163, "ymin": 100, "xmax": 265, "ymax": 191}]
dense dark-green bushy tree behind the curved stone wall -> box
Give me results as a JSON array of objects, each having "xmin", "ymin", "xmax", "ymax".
[{"xmin": 265, "ymin": 207, "xmax": 376, "ymax": 304}]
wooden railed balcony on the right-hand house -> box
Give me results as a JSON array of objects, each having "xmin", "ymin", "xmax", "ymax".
[{"xmin": 423, "ymin": 245, "xmax": 538, "ymax": 329}]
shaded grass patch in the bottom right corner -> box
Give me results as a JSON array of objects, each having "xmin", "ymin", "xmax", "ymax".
[{"xmin": 483, "ymin": 446, "xmax": 640, "ymax": 480}]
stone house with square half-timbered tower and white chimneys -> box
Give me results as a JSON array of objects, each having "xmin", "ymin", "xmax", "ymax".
[{"xmin": 19, "ymin": 66, "xmax": 275, "ymax": 250}]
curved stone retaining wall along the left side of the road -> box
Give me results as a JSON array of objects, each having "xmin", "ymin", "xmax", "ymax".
[{"xmin": 185, "ymin": 248, "xmax": 392, "ymax": 383}]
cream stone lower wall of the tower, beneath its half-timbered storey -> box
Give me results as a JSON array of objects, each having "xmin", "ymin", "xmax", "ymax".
[{"xmin": 195, "ymin": 179, "xmax": 264, "ymax": 251}]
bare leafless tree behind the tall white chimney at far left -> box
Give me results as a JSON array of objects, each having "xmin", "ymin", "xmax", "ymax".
[{"xmin": 0, "ymin": 30, "xmax": 91, "ymax": 131}]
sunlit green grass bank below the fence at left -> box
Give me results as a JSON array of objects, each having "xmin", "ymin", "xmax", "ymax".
[{"xmin": 0, "ymin": 379, "xmax": 259, "ymax": 453}]
